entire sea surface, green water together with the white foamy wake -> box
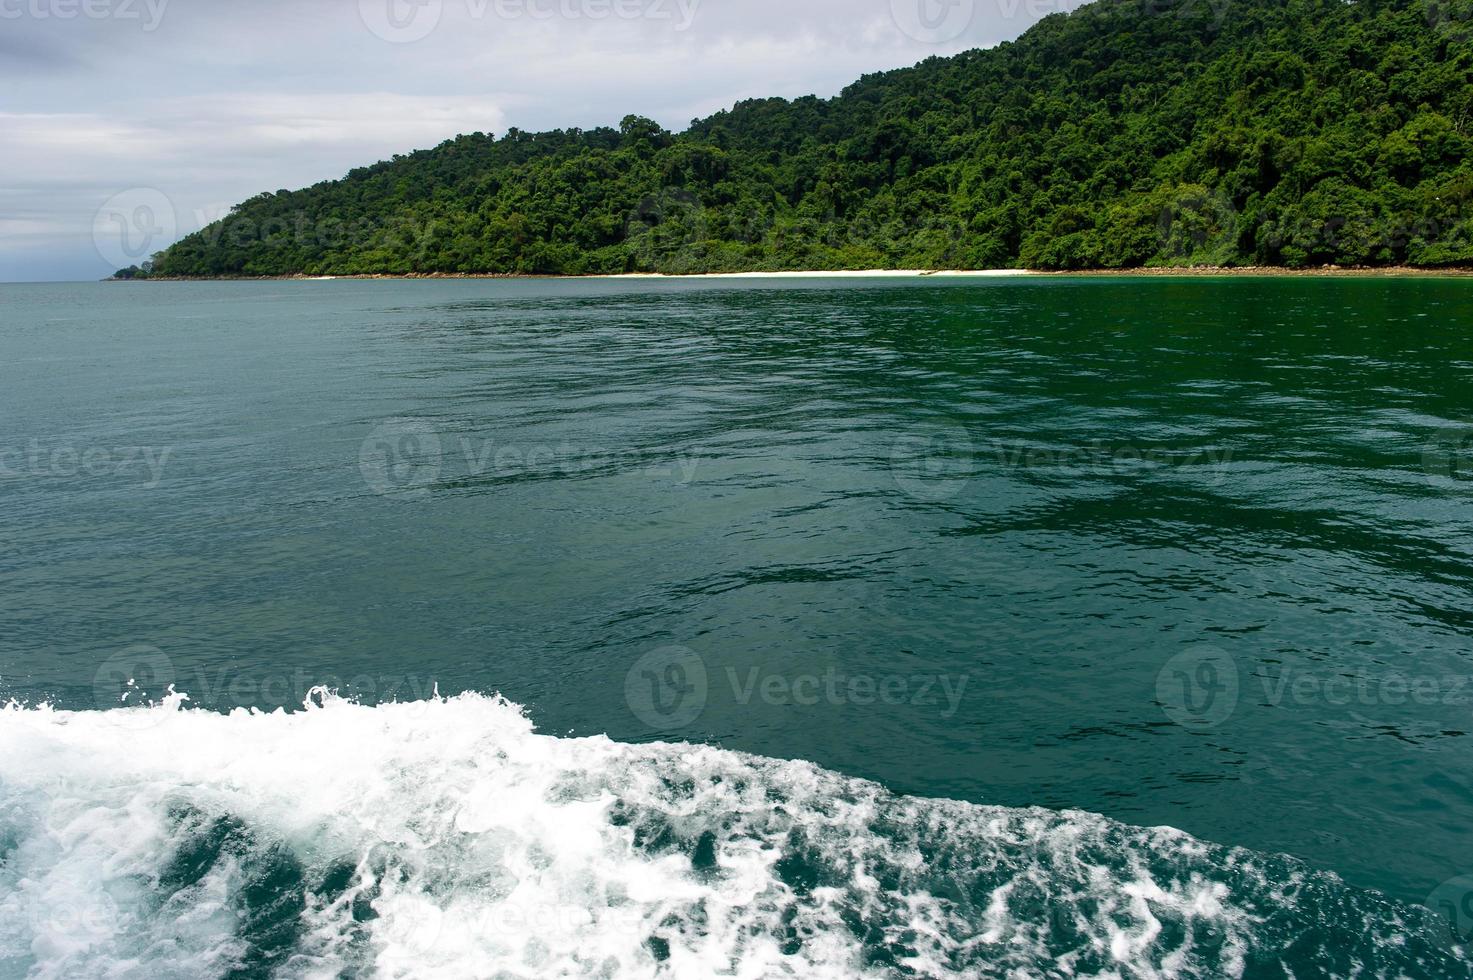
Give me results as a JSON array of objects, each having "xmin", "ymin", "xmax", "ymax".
[{"xmin": 0, "ymin": 279, "xmax": 1473, "ymax": 979}]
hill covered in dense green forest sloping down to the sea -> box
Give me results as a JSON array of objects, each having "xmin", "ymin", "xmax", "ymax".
[{"xmin": 138, "ymin": 0, "xmax": 1473, "ymax": 276}]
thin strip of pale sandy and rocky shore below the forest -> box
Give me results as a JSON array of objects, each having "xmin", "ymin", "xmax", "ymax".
[{"xmin": 114, "ymin": 265, "xmax": 1473, "ymax": 283}]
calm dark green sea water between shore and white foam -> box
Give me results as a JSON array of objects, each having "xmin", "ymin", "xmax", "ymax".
[{"xmin": 0, "ymin": 277, "xmax": 1473, "ymax": 976}]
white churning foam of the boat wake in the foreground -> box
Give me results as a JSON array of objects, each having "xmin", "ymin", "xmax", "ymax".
[{"xmin": 0, "ymin": 691, "xmax": 1469, "ymax": 979}]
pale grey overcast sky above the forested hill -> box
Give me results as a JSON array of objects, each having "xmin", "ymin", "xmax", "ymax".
[{"xmin": 0, "ymin": 0, "xmax": 1081, "ymax": 281}]
